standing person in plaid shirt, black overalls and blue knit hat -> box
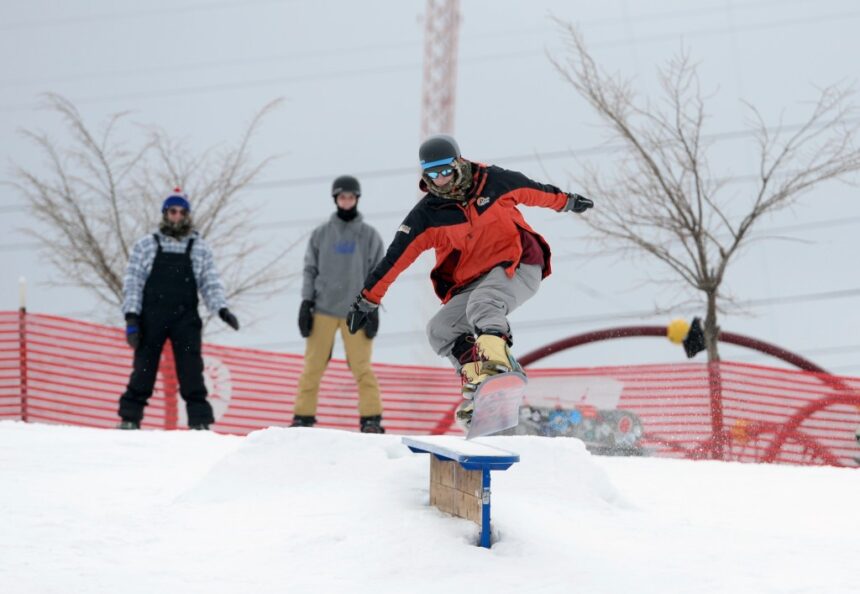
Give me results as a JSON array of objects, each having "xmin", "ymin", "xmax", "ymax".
[{"xmin": 119, "ymin": 188, "xmax": 239, "ymax": 429}]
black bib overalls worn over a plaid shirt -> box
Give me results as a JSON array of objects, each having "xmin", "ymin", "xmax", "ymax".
[{"xmin": 119, "ymin": 235, "xmax": 214, "ymax": 425}]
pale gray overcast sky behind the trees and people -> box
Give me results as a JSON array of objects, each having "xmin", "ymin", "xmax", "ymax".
[{"xmin": 0, "ymin": 0, "xmax": 860, "ymax": 375}]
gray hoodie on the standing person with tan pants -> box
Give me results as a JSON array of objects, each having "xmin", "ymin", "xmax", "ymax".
[{"xmin": 302, "ymin": 213, "xmax": 385, "ymax": 318}]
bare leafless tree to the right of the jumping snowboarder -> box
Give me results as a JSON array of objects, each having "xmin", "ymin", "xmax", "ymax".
[{"xmin": 550, "ymin": 21, "xmax": 860, "ymax": 361}]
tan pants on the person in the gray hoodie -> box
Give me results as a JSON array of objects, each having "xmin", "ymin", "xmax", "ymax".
[{"xmin": 293, "ymin": 313, "xmax": 382, "ymax": 417}]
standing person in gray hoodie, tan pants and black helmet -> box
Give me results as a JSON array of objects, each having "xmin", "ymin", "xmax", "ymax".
[{"xmin": 292, "ymin": 175, "xmax": 385, "ymax": 433}]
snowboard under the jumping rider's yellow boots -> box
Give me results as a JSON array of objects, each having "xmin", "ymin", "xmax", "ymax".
[{"xmin": 466, "ymin": 371, "xmax": 528, "ymax": 439}]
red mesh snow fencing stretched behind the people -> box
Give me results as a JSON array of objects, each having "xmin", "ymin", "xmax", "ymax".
[{"xmin": 0, "ymin": 311, "xmax": 860, "ymax": 467}]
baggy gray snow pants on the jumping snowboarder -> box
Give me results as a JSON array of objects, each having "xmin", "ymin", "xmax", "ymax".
[{"xmin": 427, "ymin": 264, "xmax": 543, "ymax": 370}]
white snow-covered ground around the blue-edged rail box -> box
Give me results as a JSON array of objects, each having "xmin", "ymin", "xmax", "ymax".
[{"xmin": 0, "ymin": 422, "xmax": 860, "ymax": 594}]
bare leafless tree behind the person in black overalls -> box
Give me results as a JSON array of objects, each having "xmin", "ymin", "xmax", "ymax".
[{"xmin": 13, "ymin": 94, "xmax": 297, "ymax": 328}]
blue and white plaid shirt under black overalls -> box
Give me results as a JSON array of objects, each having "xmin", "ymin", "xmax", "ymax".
[{"xmin": 122, "ymin": 231, "xmax": 227, "ymax": 314}]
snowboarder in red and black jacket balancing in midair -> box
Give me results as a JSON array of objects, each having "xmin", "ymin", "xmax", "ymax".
[{"xmin": 349, "ymin": 134, "xmax": 594, "ymax": 423}]
